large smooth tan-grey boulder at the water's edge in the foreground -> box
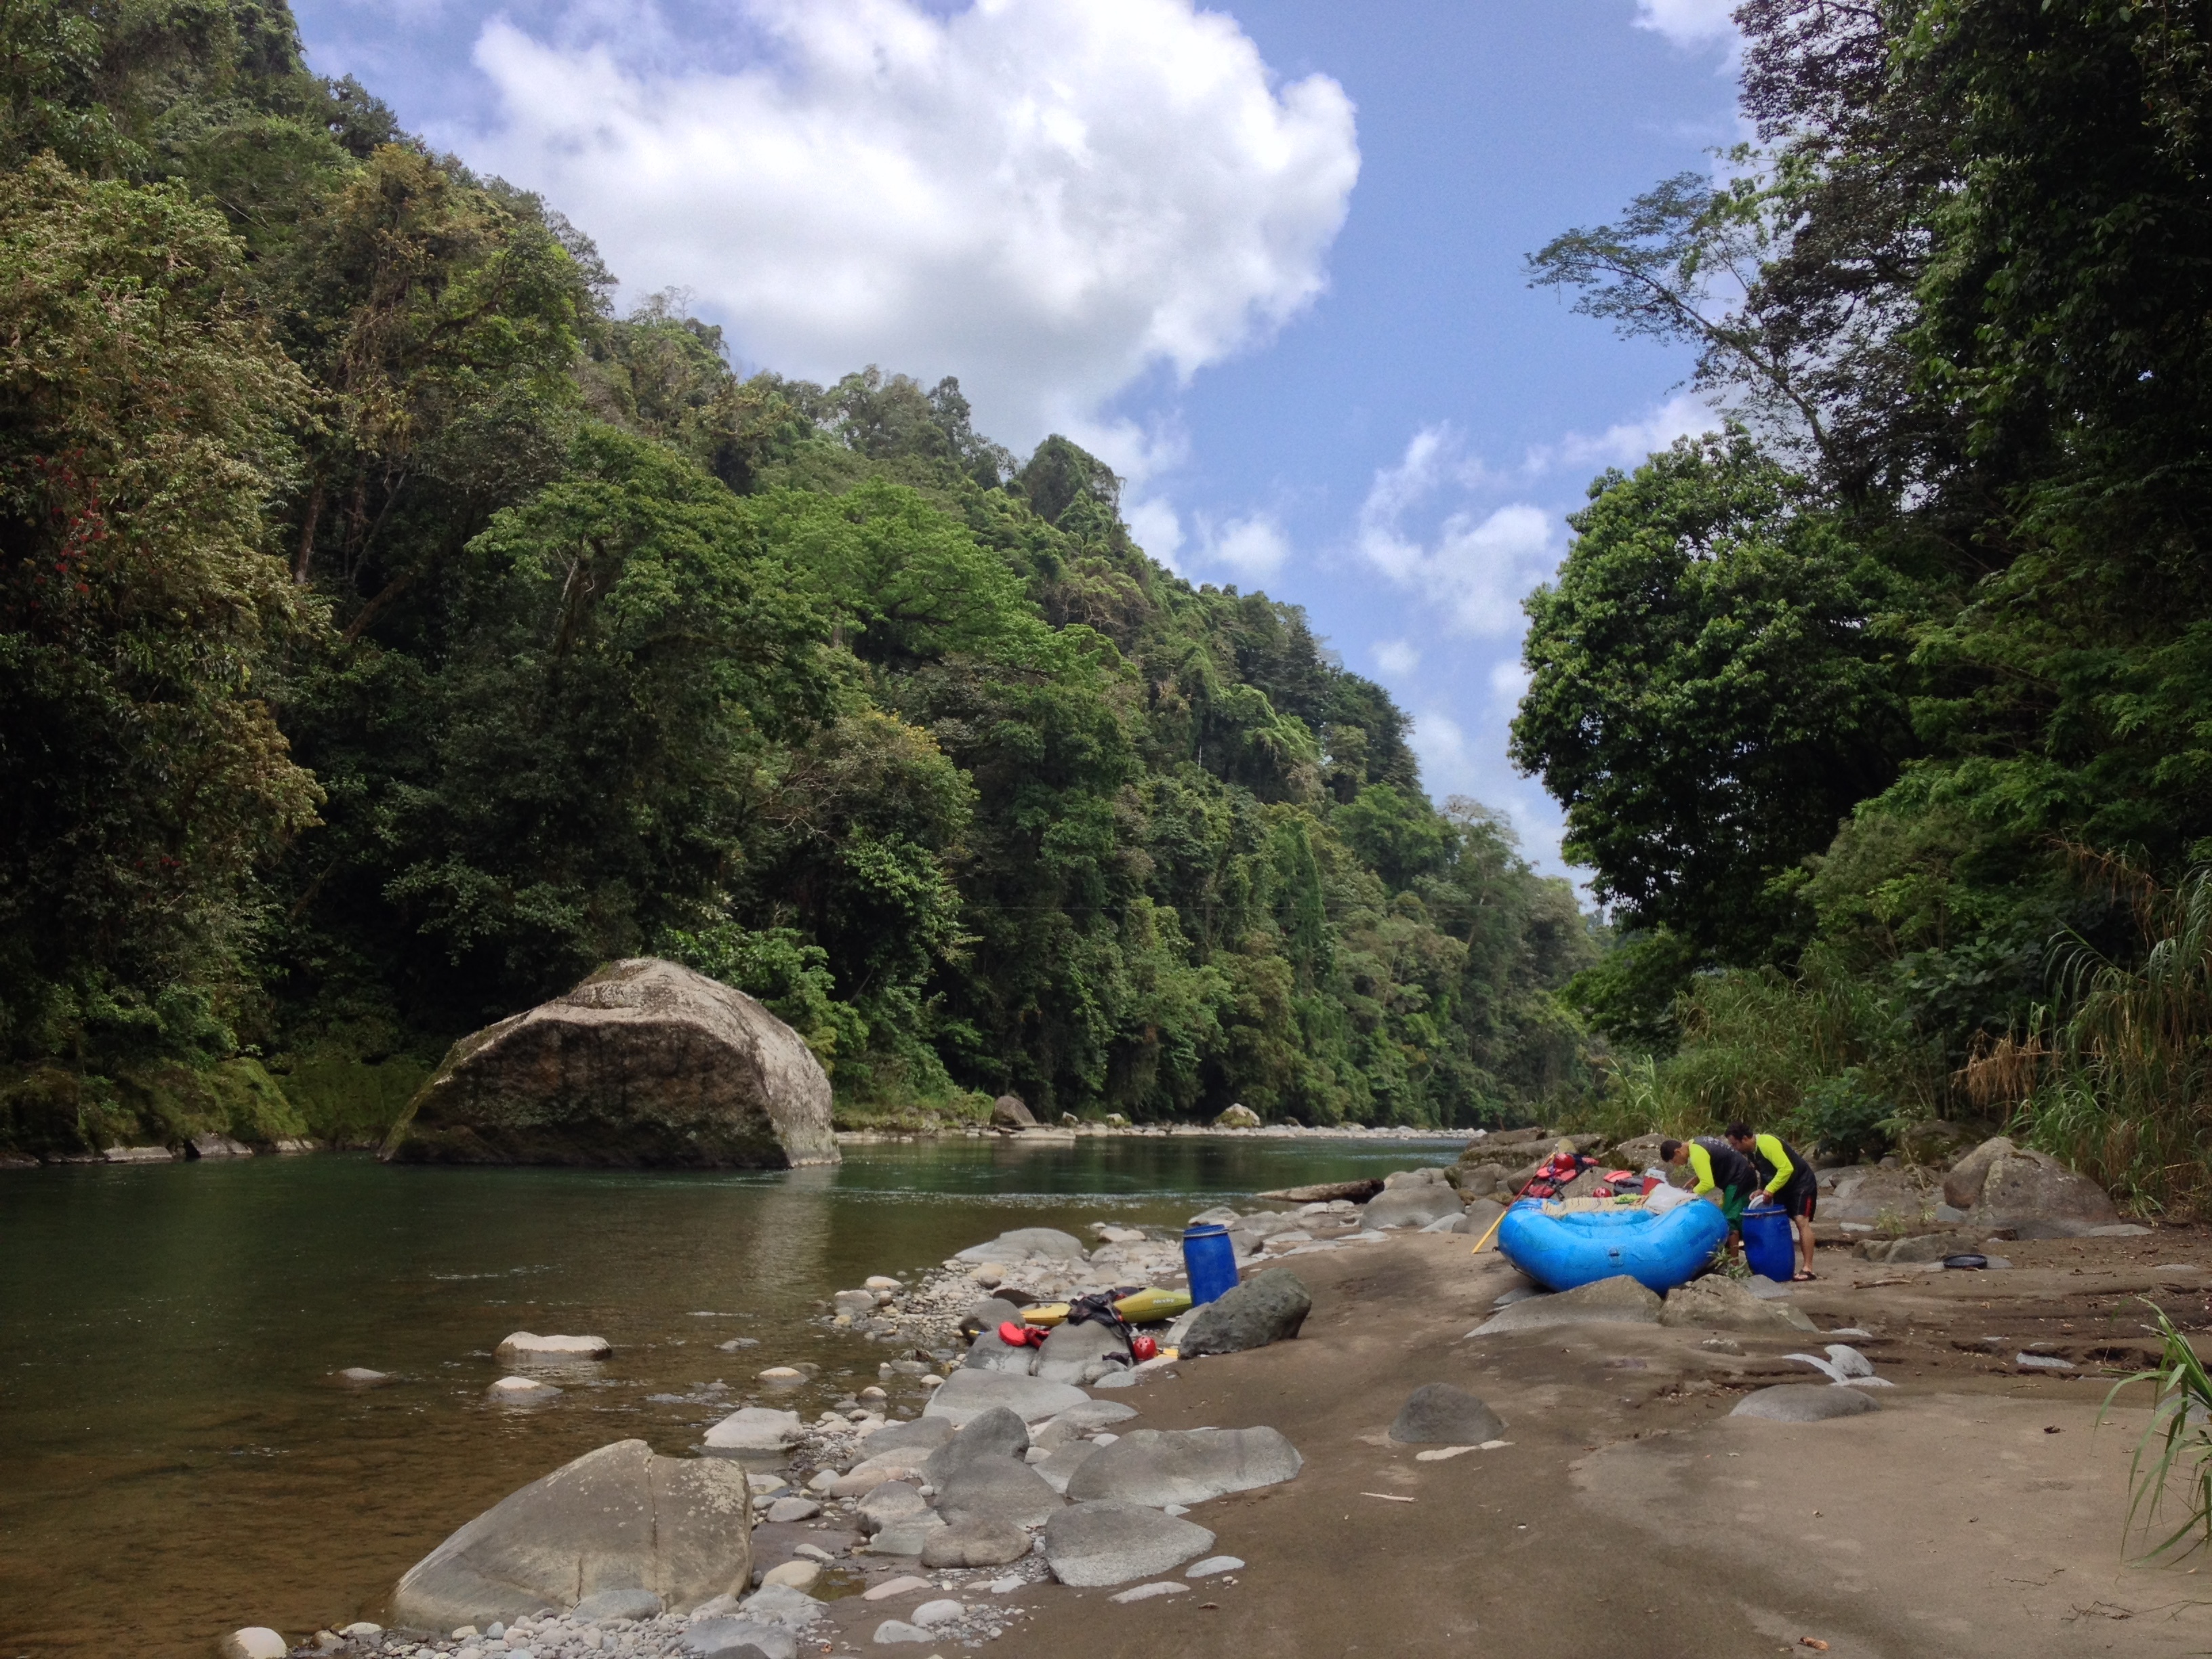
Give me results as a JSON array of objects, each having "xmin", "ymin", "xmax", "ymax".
[{"xmin": 392, "ymin": 1440, "xmax": 752, "ymax": 1631}]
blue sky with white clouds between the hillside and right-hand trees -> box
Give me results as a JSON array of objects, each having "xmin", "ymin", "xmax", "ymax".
[{"xmin": 294, "ymin": 0, "xmax": 1739, "ymax": 869}]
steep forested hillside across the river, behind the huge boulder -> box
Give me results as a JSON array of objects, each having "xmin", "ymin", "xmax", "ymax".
[{"xmin": 0, "ymin": 0, "xmax": 1597, "ymax": 1155}]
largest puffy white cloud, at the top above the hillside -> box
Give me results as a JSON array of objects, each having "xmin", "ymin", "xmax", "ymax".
[{"xmin": 469, "ymin": 0, "xmax": 1360, "ymax": 445}]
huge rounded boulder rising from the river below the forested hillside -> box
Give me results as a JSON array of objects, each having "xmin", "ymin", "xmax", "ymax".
[{"xmin": 383, "ymin": 958, "xmax": 838, "ymax": 1168}]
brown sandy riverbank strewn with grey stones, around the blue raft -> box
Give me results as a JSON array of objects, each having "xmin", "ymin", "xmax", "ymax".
[{"xmin": 216, "ymin": 1146, "xmax": 2212, "ymax": 1659}]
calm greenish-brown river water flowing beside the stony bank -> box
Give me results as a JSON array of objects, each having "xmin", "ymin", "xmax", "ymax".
[{"xmin": 0, "ymin": 1137, "xmax": 1460, "ymax": 1659}]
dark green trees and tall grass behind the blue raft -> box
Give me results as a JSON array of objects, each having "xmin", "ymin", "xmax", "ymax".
[{"xmin": 1515, "ymin": 0, "xmax": 2212, "ymax": 1206}]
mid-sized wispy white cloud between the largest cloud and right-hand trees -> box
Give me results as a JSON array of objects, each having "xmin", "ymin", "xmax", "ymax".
[{"xmin": 1358, "ymin": 427, "xmax": 1559, "ymax": 639}]
